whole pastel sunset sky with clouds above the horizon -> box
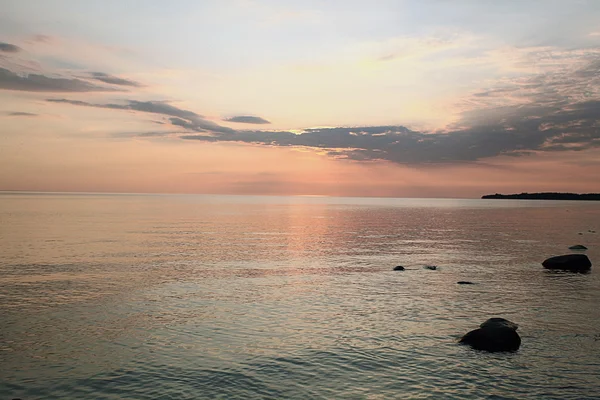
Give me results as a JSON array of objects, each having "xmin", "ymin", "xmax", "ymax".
[{"xmin": 0, "ymin": 0, "xmax": 600, "ymax": 198}]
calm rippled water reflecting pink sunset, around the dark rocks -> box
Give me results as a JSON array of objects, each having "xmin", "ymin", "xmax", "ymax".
[{"xmin": 0, "ymin": 194, "xmax": 600, "ymax": 399}]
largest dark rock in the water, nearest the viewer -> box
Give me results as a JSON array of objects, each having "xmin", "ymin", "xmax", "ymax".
[{"xmin": 459, "ymin": 318, "xmax": 521, "ymax": 352}]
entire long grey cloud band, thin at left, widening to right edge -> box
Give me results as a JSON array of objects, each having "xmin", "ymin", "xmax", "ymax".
[{"xmin": 49, "ymin": 51, "xmax": 600, "ymax": 164}]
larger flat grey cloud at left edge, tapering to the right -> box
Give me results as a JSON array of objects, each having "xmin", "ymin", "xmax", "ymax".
[{"xmin": 0, "ymin": 68, "xmax": 115, "ymax": 93}]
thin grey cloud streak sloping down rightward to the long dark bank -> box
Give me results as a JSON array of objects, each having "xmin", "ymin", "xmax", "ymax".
[{"xmin": 47, "ymin": 99, "xmax": 234, "ymax": 133}]
